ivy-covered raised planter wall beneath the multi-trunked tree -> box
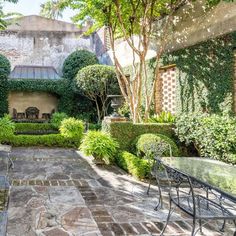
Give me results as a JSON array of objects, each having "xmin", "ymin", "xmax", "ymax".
[{"xmin": 102, "ymin": 122, "xmax": 176, "ymax": 150}]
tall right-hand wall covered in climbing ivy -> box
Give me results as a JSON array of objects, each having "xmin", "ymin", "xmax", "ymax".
[{"xmin": 124, "ymin": 32, "xmax": 236, "ymax": 113}]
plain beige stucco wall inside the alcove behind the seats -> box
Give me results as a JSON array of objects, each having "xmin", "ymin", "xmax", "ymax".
[{"xmin": 8, "ymin": 92, "xmax": 58, "ymax": 118}]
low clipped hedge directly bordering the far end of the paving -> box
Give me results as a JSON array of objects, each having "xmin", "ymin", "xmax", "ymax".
[{"xmin": 2, "ymin": 134, "xmax": 80, "ymax": 148}]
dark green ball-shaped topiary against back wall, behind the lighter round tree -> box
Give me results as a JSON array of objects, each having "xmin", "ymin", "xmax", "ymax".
[{"xmin": 62, "ymin": 50, "xmax": 99, "ymax": 80}]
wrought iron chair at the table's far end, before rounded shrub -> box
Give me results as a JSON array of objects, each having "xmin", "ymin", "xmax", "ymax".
[{"xmin": 146, "ymin": 141, "xmax": 172, "ymax": 210}]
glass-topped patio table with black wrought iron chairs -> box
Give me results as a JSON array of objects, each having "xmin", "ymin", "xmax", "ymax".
[{"xmin": 147, "ymin": 145, "xmax": 236, "ymax": 236}]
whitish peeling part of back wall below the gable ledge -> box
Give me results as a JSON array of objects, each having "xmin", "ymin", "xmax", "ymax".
[{"xmin": 0, "ymin": 31, "xmax": 93, "ymax": 73}]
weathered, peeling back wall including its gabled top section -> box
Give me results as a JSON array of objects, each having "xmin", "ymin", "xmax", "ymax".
[{"xmin": 0, "ymin": 16, "xmax": 94, "ymax": 73}]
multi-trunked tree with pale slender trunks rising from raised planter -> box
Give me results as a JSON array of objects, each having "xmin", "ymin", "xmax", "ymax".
[{"xmin": 56, "ymin": 0, "xmax": 230, "ymax": 122}]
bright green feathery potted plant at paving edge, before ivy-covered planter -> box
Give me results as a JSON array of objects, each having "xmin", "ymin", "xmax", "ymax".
[{"xmin": 80, "ymin": 131, "xmax": 119, "ymax": 164}]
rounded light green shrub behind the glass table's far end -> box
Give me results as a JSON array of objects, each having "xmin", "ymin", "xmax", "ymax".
[{"xmin": 135, "ymin": 134, "xmax": 179, "ymax": 157}]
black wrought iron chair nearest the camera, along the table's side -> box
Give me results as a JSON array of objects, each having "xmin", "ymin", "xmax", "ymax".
[{"xmin": 157, "ymin": 161, "xmax": 236, "ymax": 236}]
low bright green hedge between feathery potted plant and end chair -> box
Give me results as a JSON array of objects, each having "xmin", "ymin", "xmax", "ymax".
[{"xmin": 116, "ymin": 152, "xmax": 151, "ymax": 179}]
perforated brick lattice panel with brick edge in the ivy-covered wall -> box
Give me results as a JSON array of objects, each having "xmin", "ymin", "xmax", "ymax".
[{"xmin": 155, "ymin": 66, "xmax": 176, "ymax": 114}]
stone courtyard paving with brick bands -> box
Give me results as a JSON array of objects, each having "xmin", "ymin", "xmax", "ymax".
[{"xmin": 0, "ymin": 148, "xmax": 233, "ymax": 236}]
